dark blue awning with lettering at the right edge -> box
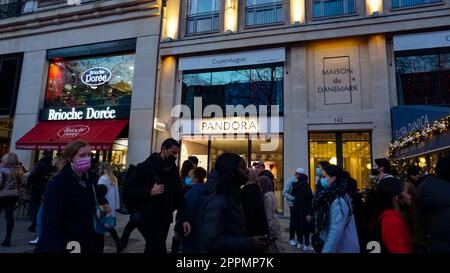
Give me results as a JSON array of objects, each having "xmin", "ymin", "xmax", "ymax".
[{"xmin": 391, "ymin": 105, "xmax": 450, "ymax": 157}]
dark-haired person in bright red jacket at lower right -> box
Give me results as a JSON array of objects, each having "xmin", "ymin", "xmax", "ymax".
[{"xmin": 369, "ymin": 177, "xmax": 413, "ymax": 253}]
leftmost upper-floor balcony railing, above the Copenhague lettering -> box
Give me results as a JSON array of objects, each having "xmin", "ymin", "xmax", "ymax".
[{"xmin": 186, "ymin": 11, "xmax": 219, "ymax": 34}]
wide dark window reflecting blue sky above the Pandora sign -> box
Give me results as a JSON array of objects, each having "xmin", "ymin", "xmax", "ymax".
[{"xmin": 182, "ymin": 66, "xmax": 283, "ymax": 114}]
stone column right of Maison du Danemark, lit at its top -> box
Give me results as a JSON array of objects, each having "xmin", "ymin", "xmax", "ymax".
[{"xmin": 369, "ymin": 34, "xmax": 391, "ymax": 159}]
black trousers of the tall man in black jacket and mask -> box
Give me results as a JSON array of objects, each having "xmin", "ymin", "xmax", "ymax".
[{"xmin": 143, "ymin": 221, "xmax": 170, "ymax": 254}]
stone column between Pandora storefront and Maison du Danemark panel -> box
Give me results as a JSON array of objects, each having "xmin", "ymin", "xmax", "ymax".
[{"xmin": 283, "ymin": 46, "xmax": 309, "ymax": 215}]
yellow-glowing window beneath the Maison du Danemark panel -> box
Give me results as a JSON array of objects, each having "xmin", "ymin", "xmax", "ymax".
[{"xmin": 309, "ymin": 132, "xmax": 371, "ymax": 190}]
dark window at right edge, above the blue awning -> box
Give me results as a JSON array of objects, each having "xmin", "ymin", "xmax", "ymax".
[{"xmin": 395, "ymin": 48, "xmax": 450, "ymax": 105}]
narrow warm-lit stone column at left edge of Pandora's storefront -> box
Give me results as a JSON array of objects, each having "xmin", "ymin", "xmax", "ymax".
[{"xmin": 153, "ymin": 56, "xmax": 181, "ymax": 152}]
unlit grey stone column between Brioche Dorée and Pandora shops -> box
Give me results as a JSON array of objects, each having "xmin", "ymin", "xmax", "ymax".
[{"xmin": 127, "ymin": 35, "xmax": 158, "ymax": 164}]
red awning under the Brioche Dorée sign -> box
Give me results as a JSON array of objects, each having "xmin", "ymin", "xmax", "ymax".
[{"xmin": 16, "ymin": 119, "xmax": 128, "ymax": 150}]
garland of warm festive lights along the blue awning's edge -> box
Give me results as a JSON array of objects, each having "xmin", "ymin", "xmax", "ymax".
[{"xmin": 387, "ymin": 115, "xmax": 450, "ymax": 158}]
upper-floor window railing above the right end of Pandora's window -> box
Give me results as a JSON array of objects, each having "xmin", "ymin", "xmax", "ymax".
[{"xmin": 245, "ymin": 1, "xmax": 283, "ymax": 26}]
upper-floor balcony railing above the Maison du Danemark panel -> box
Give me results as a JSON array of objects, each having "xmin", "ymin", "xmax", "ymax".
[{"xmin": 313, "ymin": 0, "xmax": 356, "ymax": 18}]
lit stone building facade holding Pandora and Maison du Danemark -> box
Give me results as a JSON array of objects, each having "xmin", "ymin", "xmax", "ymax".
[{"xmin": 153, "ymin": 0, "xmax": 450, "ymax": 211}]
